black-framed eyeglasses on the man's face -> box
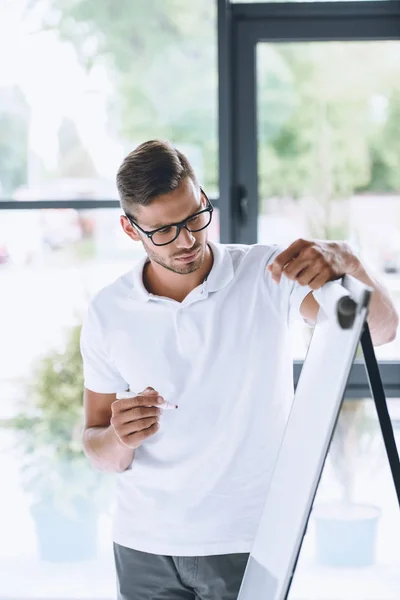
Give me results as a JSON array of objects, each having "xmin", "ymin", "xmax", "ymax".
[{"xmin": 125, "ymin": 188, "xmax": 214, "ymax": 246}]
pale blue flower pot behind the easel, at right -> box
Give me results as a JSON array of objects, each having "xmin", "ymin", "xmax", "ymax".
[{"xmin": 313, "ymin": 504, "xmax": 381, "ymax": 567}]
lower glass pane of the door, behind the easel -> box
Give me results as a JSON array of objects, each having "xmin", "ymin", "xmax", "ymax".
[{"xmin": 289, "ymin": 398, "xmax": 400, "ymax": 600}]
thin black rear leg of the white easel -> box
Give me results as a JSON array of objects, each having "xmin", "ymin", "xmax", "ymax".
[{"xmin": 361, "ymin": 324, "xmax": 400, "ymax": 505}]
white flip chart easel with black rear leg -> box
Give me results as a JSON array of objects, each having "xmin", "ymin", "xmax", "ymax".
[{"xmin": 238, "ymin": 275, "xmax": 400, "ymax": 600}]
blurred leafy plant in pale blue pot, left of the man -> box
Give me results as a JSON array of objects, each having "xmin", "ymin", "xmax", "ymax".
[{"xmin": 3, "ymin": 326, "xmax": 111, "ymax": 562}]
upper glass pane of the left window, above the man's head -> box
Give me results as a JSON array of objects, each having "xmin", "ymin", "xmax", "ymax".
[{"xmin": 0, "ymin": 0, "xmax": 218, "ymax": 200}]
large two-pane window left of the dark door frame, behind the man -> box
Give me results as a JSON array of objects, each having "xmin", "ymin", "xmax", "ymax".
[{"xmin": 0, "ymin": 0, "xmax": 219, "ymax": 598}]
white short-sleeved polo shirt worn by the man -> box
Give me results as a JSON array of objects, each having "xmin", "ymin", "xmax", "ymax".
[{"xmin": 81, "ymin": 243, "xmax": 311, "ymax": 556}]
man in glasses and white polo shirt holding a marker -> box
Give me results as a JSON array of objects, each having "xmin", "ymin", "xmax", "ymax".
[{"xmin": 81, "ymin": 141, "xmax": 398, "ymax": 600}]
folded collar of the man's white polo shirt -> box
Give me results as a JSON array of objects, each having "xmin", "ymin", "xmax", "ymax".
[{"xmin": 132, "ymin": 241, "xmax": 234, "ymax": 302}]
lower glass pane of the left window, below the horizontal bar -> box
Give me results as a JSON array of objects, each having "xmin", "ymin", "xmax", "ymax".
[{"xmin": 0, "ymin": 209, "xmax": 219, "ymax": 600}]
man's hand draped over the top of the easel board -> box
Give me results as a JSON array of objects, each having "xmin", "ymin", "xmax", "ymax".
[{"xmin": 267, "ymin": 239, "xmax": 357, "ymax": 290}]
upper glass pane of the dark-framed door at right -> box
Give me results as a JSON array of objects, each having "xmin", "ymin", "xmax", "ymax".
[{"xmin": 257, "ymin": 42, "xmax": 400, "ymax": 359}]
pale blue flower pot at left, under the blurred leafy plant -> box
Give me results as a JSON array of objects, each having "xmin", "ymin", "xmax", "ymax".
[{"xmin": 31, "ymin": 500, "xmax": 97, "ymax": 562}]
